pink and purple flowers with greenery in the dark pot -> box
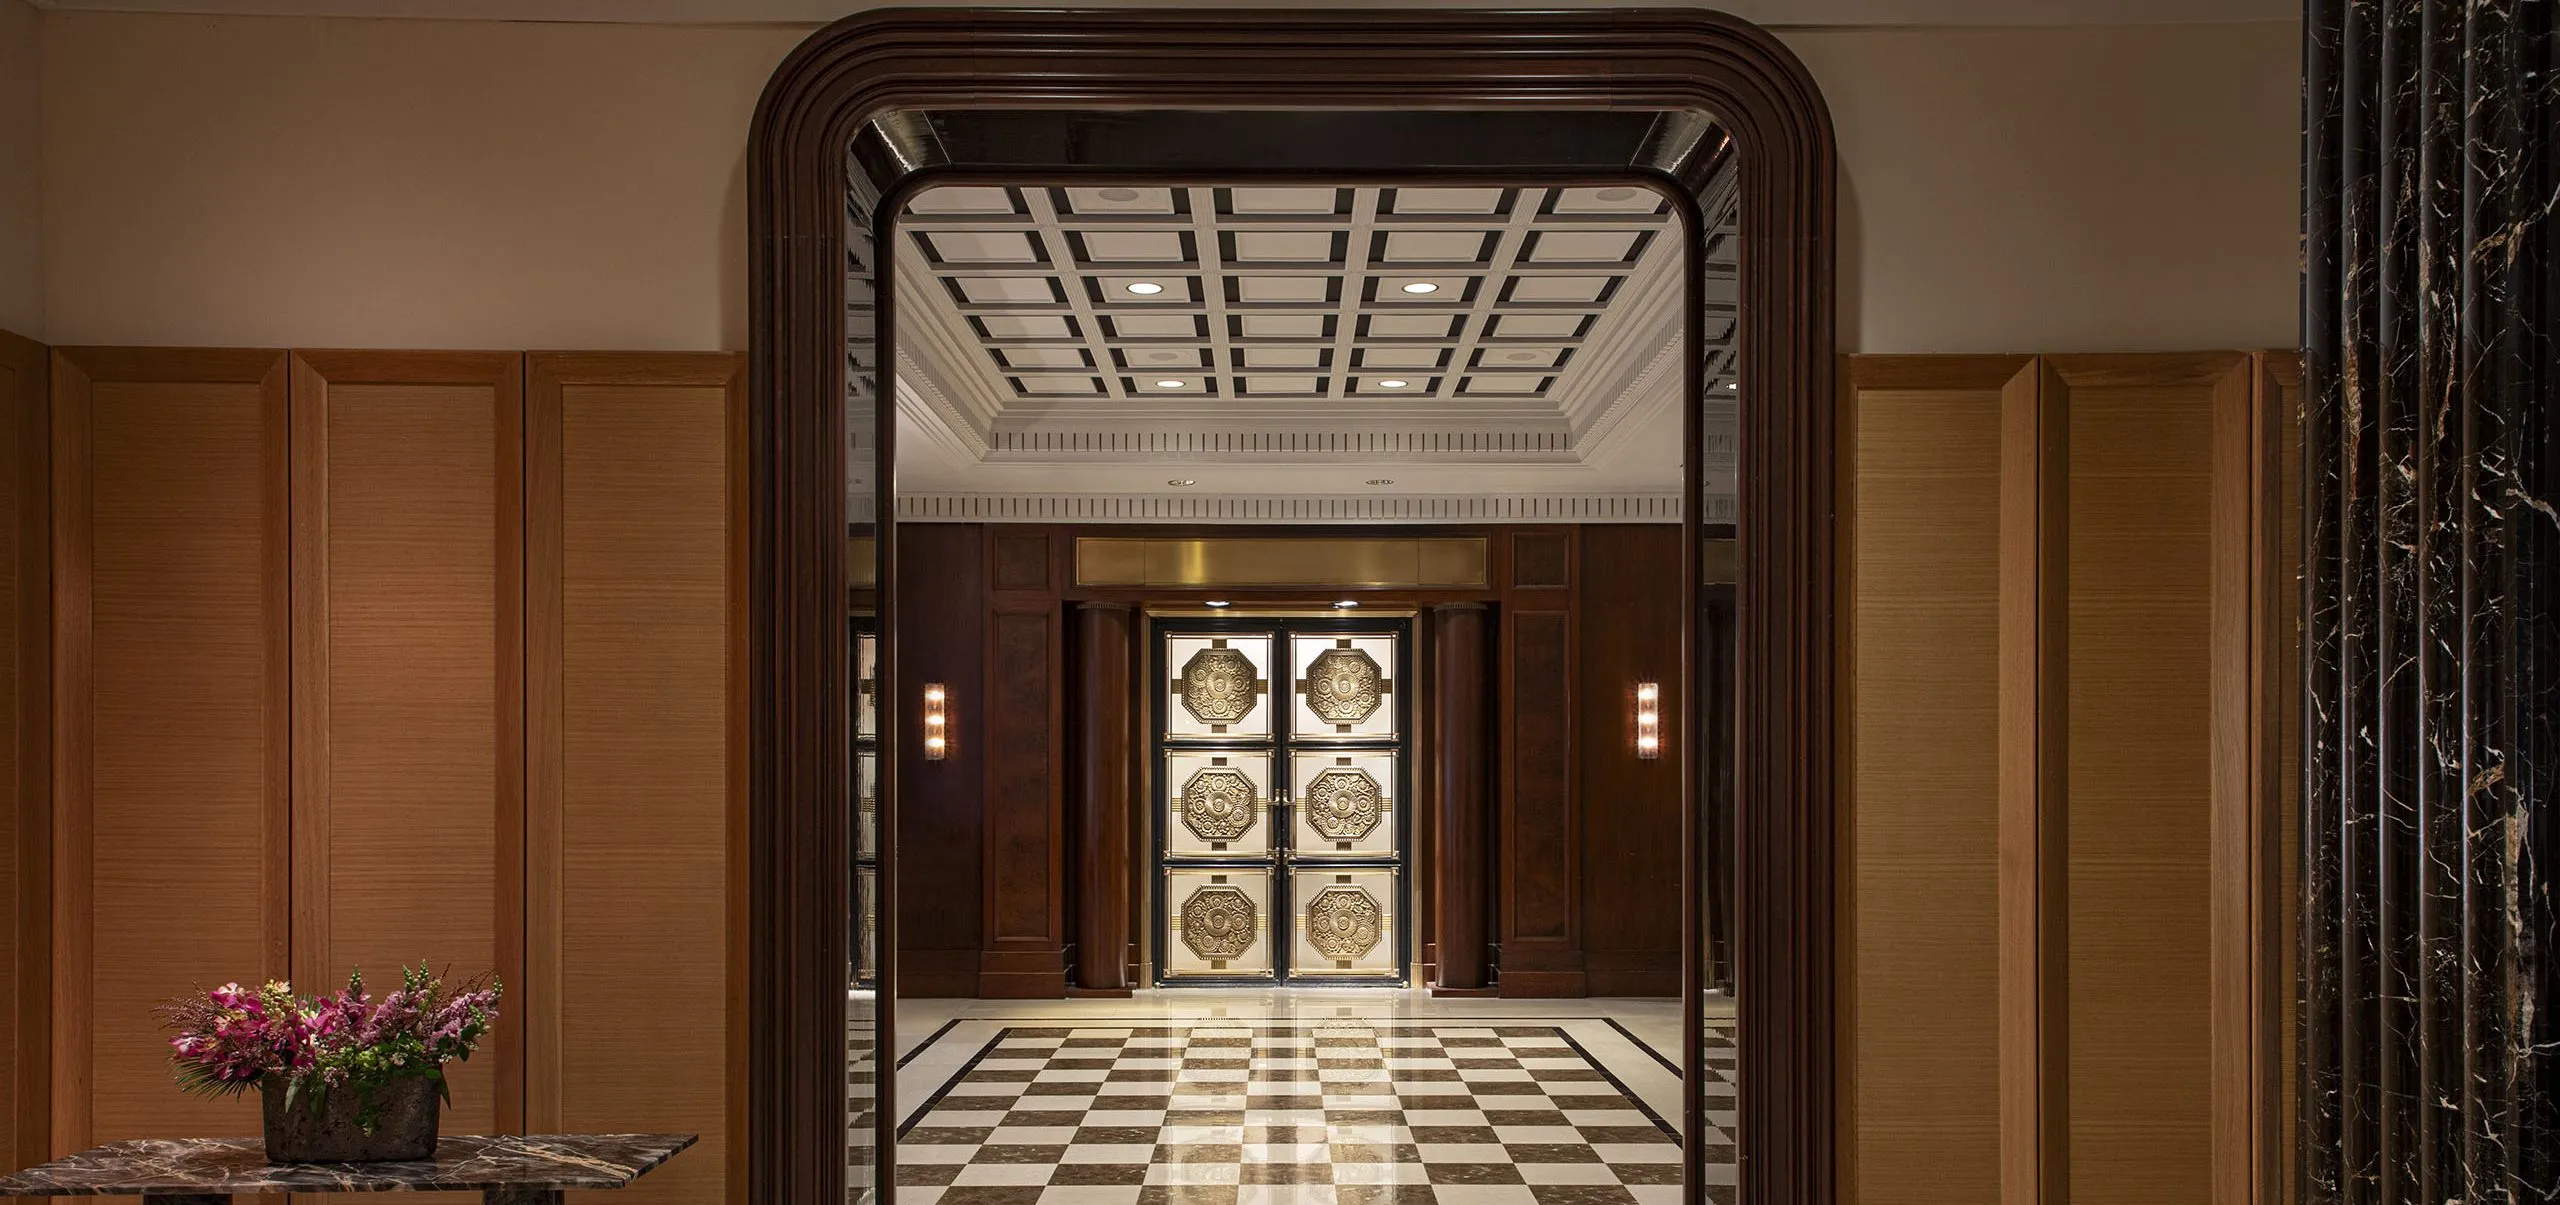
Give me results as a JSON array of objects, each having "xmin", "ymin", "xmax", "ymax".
[{"xmin": 161, "ymin": 967, "xmax": 502, "ymax": 1133}]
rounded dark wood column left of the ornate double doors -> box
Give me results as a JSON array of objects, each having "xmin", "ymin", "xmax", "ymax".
[{"xmin": 1075, "ymin": 604, "xmax": 1134, "ymax": 993}]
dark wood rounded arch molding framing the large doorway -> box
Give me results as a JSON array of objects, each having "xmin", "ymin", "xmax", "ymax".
[{"xmin": 740, "ymin": 8, "xmax": 1841, "ymax": 1205}]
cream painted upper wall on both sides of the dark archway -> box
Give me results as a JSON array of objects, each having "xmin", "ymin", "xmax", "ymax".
[{"xmin": 35, "ymin": 11, "xmax": 2299, "ymax": 350}]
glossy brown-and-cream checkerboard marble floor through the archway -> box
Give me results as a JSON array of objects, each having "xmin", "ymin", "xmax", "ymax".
[{"xmin": 896, "ymin": 1011, "xmax": 1733, "ymax": 1205}]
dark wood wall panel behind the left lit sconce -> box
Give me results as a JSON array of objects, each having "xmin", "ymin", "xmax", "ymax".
[{"xmin": 881, "ymin": 524, "xmax": 988, "ymax": 995}]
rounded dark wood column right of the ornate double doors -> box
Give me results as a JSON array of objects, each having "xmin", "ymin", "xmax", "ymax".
[{"xmin": 1431, "ymin": 604, "xmax": 1492, "ymax": 993}]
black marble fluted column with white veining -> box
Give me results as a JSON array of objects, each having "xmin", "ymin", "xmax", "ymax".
[{"xmin": 2301, "ymin": 0, "xmax": 2560, "ymax": 1205}]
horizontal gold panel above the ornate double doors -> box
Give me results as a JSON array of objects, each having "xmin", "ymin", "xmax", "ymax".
[{"xmin": 1075, "ymin": 535, "xmax": 1492, "ymax": 588}]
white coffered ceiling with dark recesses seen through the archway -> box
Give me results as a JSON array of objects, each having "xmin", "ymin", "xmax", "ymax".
[{"xmin": 896, "ymin": 184, "xmax": 1736, "ymax": 522}]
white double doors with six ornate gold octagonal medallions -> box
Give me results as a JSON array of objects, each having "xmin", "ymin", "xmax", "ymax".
[{"xmin": 1149, "ymin": 617, "xmax": 1413, "ymax": 985}]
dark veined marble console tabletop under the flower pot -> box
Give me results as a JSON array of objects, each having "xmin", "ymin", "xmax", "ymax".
[{"xmin": 0, "ymin": 1133, "xmax": 694, "ymax": 1205}]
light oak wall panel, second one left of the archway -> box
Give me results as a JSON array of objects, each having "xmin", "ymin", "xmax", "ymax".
[{"xmin": 292, "ymin": 350, "xmax": 525, "ymax": 1133}]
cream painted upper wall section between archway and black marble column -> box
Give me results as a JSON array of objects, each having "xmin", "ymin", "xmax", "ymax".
[{"xmin": 1787, "ymin": 23, "xmax": 2301, "ymax": 353}]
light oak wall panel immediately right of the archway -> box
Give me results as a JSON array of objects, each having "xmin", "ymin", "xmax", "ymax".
[{"xmin": 1843, "ymin": 356, "xmax": 2033, "ymax": 1205}]
